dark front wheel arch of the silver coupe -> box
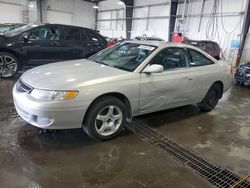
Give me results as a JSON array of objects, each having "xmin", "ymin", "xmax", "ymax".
[{"xmin": 83, "ymin": 92, "xmax": 132, "ymax": 123}]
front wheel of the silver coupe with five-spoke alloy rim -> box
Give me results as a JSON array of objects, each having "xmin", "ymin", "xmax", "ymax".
[{"xmin": 83, "ymin": 96, "xmax": 127, "ymax": 141}]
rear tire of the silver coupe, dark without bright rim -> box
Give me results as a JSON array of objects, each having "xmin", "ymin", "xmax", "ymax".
[{"xmin": 198, "ymin": 83, "xmax": 223, "ymax": 112}]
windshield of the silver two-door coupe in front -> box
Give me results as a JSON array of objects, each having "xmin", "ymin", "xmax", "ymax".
[{"xmin": 89, "ymin": 43, "xmax": 156, "ymax": 72}]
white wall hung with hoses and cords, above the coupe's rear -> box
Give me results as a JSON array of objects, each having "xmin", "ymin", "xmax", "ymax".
[{"xmin": 176, "ymin": 0, "xmax": 247, "ymax": 64}]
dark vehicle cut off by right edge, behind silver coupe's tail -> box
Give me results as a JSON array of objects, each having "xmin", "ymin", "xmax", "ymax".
[{"xmin": 234, "ymin": 62, "xmax": 250, "ymax": 85}]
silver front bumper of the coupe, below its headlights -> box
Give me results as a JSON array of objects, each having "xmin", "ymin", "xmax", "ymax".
[{"xmin": 12, "ymin": 86, "xmax": 86, "ymax": 129}]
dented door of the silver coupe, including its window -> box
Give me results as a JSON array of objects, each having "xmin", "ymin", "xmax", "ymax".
[{"xmin": 139, "ymin": 48, "xmax": 198, "ymax": 112}]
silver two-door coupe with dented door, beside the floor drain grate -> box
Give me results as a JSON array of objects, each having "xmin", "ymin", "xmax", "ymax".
[{"xmin": 13, "ymin": 42, "xmax": 232, "ymax": 140}]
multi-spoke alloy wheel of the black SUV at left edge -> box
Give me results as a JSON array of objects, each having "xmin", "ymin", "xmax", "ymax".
[{"xmin": 0, "ymin": 52, "xmax": 20, "ymax": 78}]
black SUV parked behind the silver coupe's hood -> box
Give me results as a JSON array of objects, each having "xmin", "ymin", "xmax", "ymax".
[{"xmin": 0, "ymin": 24, "xmax": 107, "ymax": 78}]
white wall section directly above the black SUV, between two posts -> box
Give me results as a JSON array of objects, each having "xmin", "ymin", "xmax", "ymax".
[{"xmin": 45, "ymin": 0, "xmax": 95, "ymax": 29}]
